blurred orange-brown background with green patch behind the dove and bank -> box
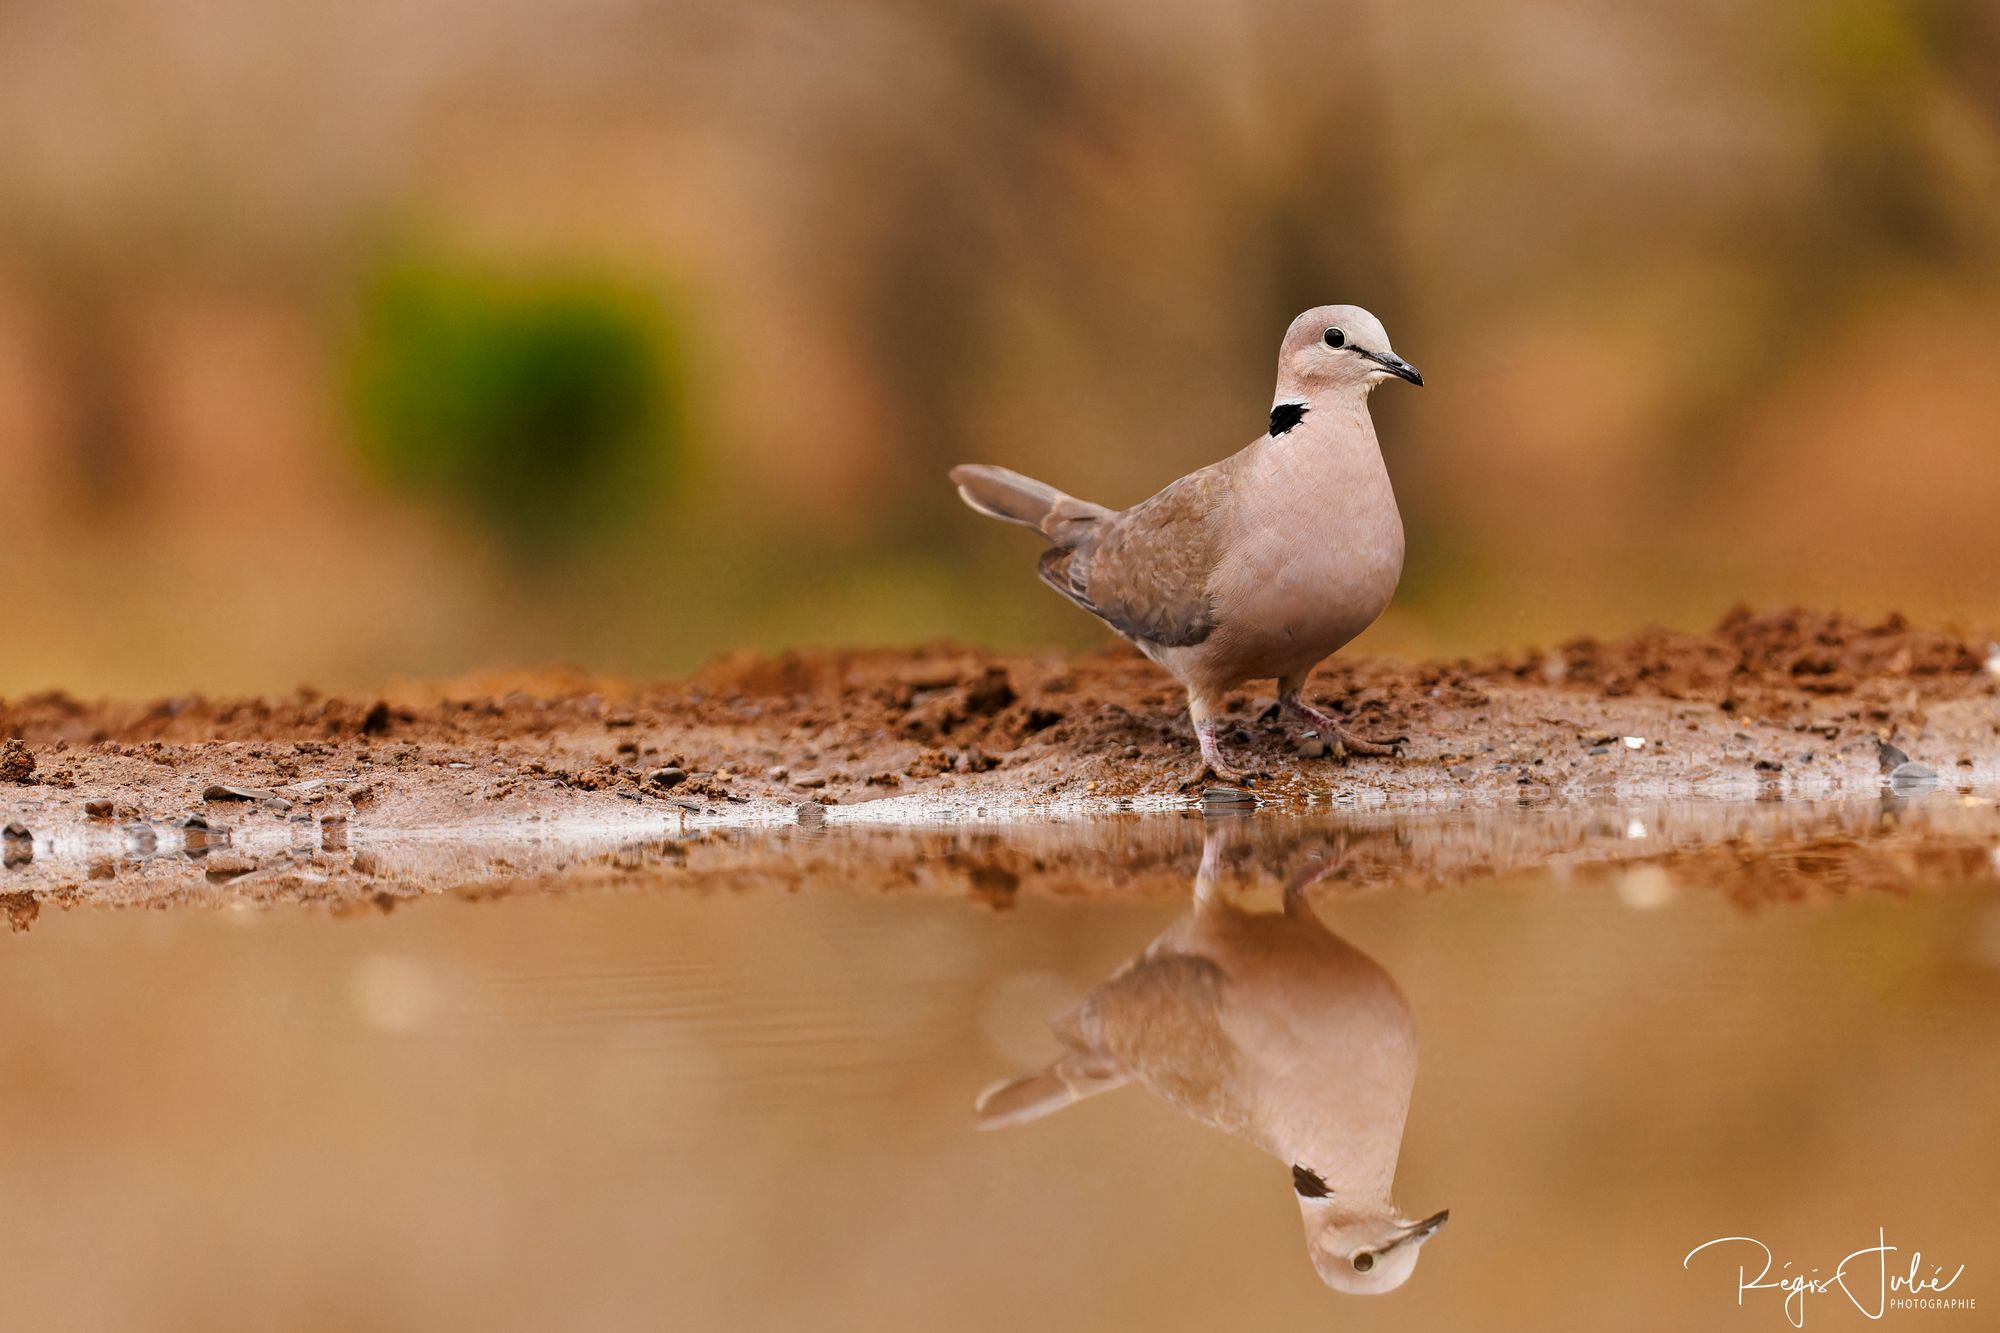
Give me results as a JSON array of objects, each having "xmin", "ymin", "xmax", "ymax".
[{"xmin": 0, "ymin": 0, "xmax": 2000, "ymax": 695}]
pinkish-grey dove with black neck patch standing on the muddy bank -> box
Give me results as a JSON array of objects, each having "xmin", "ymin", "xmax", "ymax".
[{"xmin": 950, "ymin": 306, "xmax": 1424, "ymax": 781}]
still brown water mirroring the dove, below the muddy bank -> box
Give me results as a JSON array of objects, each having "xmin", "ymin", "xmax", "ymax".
[{"xmin": 0, "ymin": 793, "xmax": 2000, "ymax": 1331}]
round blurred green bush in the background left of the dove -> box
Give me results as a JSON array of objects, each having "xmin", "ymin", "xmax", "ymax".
[{"xmin": 348, "ymin": 258, "xmax": 688, "ymax": 558}]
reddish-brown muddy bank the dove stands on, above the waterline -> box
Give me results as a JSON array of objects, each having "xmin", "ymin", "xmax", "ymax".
[{"xmin": 0, "ymin": 610, "xmax": 2000, "ymax": 829}]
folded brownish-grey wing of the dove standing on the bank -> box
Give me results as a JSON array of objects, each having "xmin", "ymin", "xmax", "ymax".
[{"xmin": 1042, "ymin": 464, "xmax": 1232, "ymax": 648}]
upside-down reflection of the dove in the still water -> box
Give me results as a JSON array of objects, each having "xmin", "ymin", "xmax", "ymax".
[{"xmin": 978, "ymin": 825, "xmax": 1448, "ymax": 1295}]
